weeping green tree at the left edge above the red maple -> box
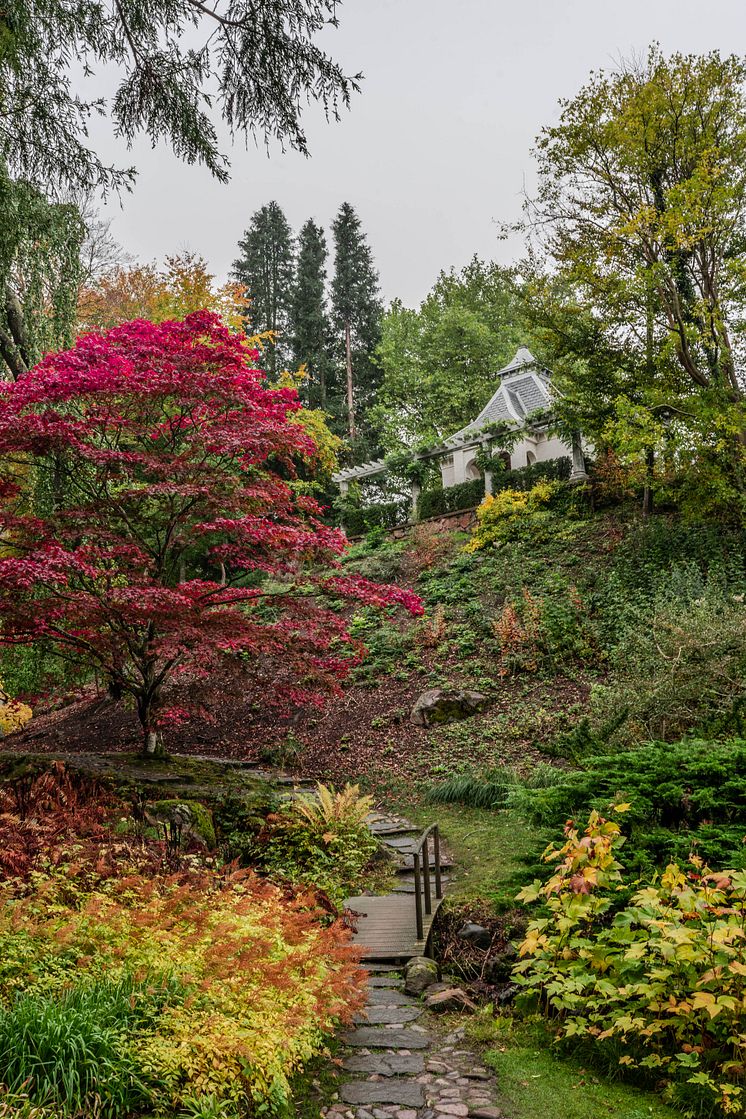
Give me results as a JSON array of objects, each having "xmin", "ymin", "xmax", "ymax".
[{"xmin": 0, "ymin": 164, "xmax": 85, "ymax": 380}]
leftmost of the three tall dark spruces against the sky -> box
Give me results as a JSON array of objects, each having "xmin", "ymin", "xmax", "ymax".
[{"xmin": 233, "ymin": 201, "xmax": 295, "ymax": 377}]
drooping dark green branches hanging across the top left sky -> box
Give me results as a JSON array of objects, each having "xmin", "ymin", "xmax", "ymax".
[{"xmin": 0, "ymin": 0, "xmax": 359, "ymax": 189}]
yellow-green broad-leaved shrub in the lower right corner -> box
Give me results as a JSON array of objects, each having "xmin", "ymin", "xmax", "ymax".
[{"xmin": 514, "ymin": 805, "xmax": 746, "ymax": 1116}]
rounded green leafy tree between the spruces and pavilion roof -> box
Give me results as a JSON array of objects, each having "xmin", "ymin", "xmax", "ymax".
[{"xmin": 375, "ymin": 257, "xmax": 528, "ymax": 449}]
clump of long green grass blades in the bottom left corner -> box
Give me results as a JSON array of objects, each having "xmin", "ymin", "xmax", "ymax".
[{"xmin": 0, "ymin": 979, "xmax": 181, "ymax": 1119}]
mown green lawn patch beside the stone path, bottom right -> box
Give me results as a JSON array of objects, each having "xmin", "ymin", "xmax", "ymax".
[{"xmin": 468, "ymin": 1015, "xmax": 681, "ymax": 1119}]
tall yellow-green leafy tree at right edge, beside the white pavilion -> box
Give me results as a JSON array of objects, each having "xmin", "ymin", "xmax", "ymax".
[{"xmin": 529, "ymin": 46, "xmax": 746, "ymax": 509}]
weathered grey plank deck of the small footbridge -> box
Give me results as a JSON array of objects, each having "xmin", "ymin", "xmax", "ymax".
[{"xmin": 344, "ymin": 894, "xmax": 441, "ymax": 960}]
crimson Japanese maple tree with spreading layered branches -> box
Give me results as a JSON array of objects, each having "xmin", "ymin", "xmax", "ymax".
[{"xmin": 0, "ymin": 312, "xmax": 422, "ymax": 752}]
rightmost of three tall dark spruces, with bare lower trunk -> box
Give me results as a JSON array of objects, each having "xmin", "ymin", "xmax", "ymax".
[{"xmin": 331, "ymin": 203, "xmax": 383, "ymax": 444}]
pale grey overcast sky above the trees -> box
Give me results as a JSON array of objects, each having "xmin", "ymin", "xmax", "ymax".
[{"xmin": 93, "ymin": 0, "xmax": 746, "ymax": 305}]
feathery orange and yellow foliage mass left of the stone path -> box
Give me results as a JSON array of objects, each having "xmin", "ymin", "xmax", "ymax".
[{"xmin": 0, "ymin": 865, "xmax": 365, "ymax": 1116}]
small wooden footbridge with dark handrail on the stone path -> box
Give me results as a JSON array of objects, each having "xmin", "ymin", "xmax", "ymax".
[{"xmin": 344, "ymin": 815, "xmax": 451, "ymax": 962}]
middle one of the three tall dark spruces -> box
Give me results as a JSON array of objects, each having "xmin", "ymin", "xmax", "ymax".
[{"xmin": 291, "ymin": 218, "xmax": 333, "ymax": 411}]
